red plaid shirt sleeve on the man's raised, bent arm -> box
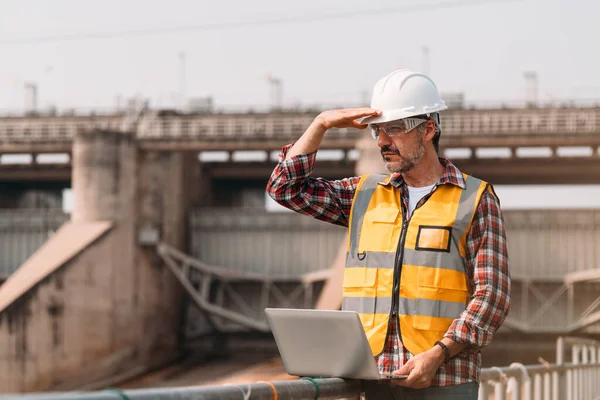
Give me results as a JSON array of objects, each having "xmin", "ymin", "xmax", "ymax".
[{"xmin": 267, "ymin": 144, "xmax": 360, "ymax": 227}]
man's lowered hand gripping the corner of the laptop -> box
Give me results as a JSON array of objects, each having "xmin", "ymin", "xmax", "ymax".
[{"xmin": 391, "ymin": 346, "xmax": 444, "ymax": 389}]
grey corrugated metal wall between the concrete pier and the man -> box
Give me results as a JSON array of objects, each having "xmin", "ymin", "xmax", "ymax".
[{"xmin": 190, "ymin": 209, "xmax": 345, "ymax": 278}]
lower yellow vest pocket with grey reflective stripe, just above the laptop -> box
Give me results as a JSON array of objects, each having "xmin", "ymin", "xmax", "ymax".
[{"xmin": 342, "ymin": 266, "xmax": 377, "ymax": 328}]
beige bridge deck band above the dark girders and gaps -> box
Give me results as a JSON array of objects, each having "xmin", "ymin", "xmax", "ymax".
[{"xmin": 0, "ymin": 107, "xmax": 600, "ymax": 153}]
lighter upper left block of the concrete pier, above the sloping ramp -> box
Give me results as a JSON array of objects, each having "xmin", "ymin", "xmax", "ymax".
[{"xmin": 71, "ymin": 130, "xmax": 135, "ymax": 222}]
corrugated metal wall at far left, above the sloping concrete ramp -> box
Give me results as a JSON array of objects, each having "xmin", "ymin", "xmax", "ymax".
[{"xmin": 0, "ymin": 209, "xmax": 69, "ymax": 278}]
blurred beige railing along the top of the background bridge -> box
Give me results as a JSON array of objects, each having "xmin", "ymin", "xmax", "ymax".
[{"xmin": 0, "ymin": 107, "xmax": 600, "ymax": 142}]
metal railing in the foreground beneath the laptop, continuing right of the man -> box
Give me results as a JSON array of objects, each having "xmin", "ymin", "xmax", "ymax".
[{"xmin": 0, "ymin": 337, "xmax": 600, "ymax": 400}]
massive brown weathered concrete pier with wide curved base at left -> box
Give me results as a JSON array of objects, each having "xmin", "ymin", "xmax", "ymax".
[{"xmin": 0, "ymin": 131, "xmax": 186, "ymax": 392}]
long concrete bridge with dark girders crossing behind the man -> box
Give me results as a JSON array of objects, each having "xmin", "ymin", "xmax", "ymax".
[{"xmin": 0, "ymin": 107, "xmax": 600, "ymax": 184}]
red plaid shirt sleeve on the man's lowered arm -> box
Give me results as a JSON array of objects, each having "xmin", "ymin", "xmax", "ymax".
[{"xmin": 445, "ymin": 188, "xmax": 511, "ymax": 351}]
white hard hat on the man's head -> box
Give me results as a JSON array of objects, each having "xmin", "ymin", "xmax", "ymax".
[{"xmin": 360, "ymin": 69, "xmax": 448, "ymax": 124}]
